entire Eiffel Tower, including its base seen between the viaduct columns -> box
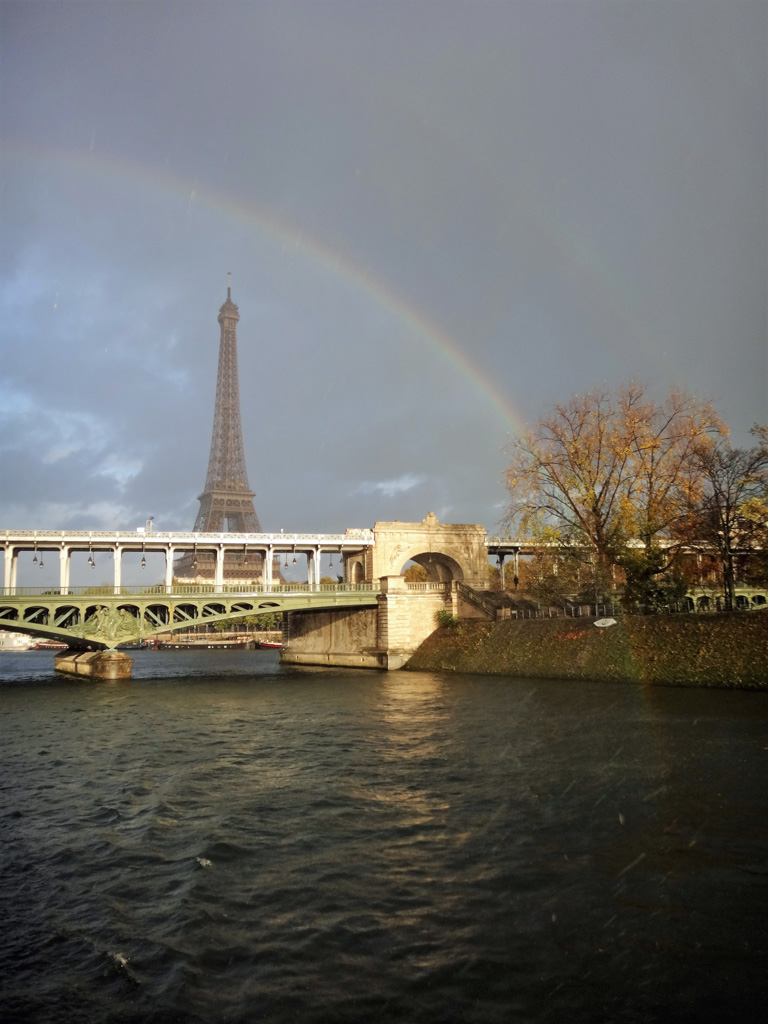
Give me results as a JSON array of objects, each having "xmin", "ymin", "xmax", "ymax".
[{"xmin": 174, "ymin": 274, "xmax": 263, "ymax": 581}]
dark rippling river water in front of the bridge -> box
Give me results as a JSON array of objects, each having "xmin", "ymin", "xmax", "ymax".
[{"xmin": 0, "ymin": 651, "xmax": 768, "ymax": 1024}]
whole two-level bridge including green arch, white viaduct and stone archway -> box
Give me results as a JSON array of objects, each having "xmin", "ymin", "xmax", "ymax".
[{"xmin": 0, "ymin": 513, "xmax": 499, "ymax": 667}]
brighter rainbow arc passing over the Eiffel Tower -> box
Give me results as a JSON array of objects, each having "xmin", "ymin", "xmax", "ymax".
[{"xmin": 4, "ymin": 139, "xmax": 522, "ymax": 433}]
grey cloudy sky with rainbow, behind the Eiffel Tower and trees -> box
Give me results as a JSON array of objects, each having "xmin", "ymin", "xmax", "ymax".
[{"xmin": 0, "ymin": 0, "xmax": 768, "ymax": 569}]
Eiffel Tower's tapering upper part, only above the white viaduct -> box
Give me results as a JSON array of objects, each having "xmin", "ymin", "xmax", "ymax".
[{"xmin": 195, "ymin": 274, "xmax": 261, "ymax": 534}]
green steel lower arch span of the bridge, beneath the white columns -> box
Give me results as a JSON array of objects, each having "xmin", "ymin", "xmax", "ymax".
[{"xmin": 0, "ymin": 584, "xmax": 379, "ymax": 647}]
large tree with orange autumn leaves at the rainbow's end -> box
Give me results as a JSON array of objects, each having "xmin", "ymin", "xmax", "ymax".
[{"xmin": 504, "ymin": 382, "xmax": 741, "ymax": 603}]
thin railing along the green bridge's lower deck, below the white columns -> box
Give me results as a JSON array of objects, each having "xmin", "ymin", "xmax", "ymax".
[{"xmin": 0, "ymin": 583, "xmax": 380, "ymax": 598}]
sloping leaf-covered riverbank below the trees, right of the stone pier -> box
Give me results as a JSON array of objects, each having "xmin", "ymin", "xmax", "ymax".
[{"xmin": 407, "ymin": 612, "xmax": 768, "ymax": 689}]
